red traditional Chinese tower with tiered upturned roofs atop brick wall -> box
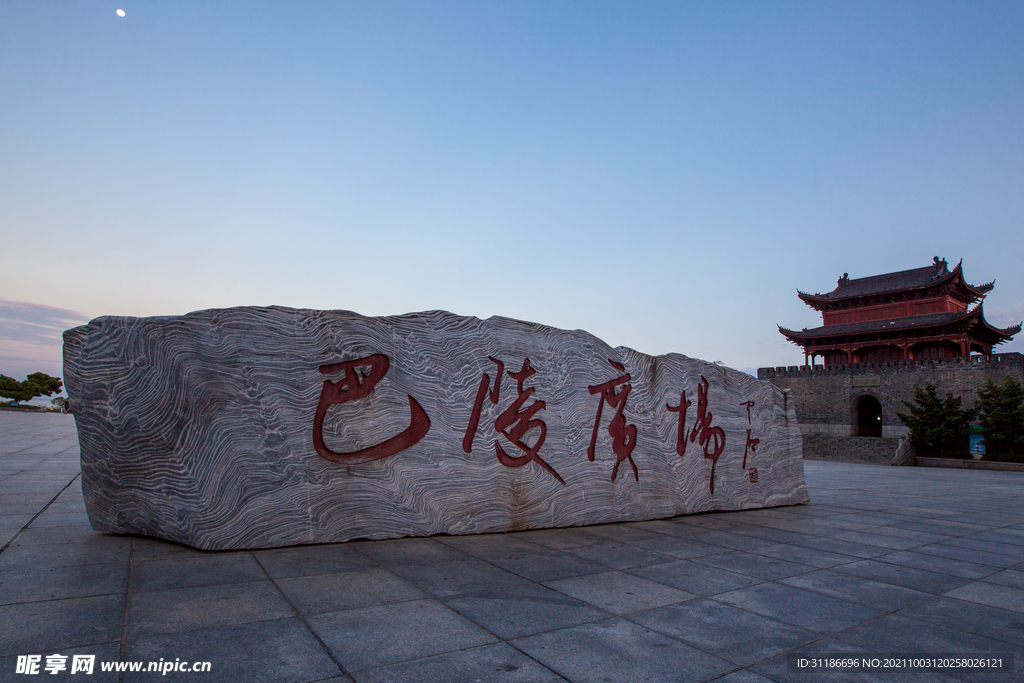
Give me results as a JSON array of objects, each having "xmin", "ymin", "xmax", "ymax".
[{"xmin": 779, "ymin": 256, "xmax": 1021, "ymax": 366}]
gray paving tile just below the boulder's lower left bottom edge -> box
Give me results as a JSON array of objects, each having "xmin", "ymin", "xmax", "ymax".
[{"xmin": 131, "ymin": 552, "xmax": 266, "ymax": 592}]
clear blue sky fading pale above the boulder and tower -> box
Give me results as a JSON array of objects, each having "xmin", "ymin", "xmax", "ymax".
[{"xmin": 0, "ymin": 0, "xmax": 1024, "ymax": 387}]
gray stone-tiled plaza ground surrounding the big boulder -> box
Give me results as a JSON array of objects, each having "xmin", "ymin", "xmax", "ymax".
[{"xmin": 0, "ymin": 412, "xmax": 1024, "ymax": 683}]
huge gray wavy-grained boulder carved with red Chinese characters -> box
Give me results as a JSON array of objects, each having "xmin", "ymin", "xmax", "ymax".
[{"xmin": 65, "ymin": 307, "xmax": 808, "ymax": 549}]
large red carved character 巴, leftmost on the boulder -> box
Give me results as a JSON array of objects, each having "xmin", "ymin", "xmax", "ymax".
[{"xmin": 313, "ymin": 353, "xmax": 430, "ymax": 465}]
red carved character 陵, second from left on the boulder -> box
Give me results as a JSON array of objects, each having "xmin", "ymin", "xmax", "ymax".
[{"xmin": 462, "ymin": 356, "xmax": 565, "ymax": 486}]
